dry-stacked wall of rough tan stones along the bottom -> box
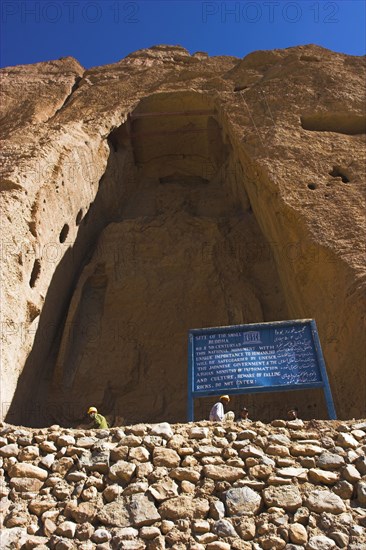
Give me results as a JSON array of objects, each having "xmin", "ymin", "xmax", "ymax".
[{"xmin": 0, "ymin": 420, "xmax": 366, "ymax": 550}]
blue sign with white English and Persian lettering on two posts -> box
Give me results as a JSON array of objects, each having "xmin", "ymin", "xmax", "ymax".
[{"xmin": 188, "ymin": 319, "xmax": 336, "ymax": 420}]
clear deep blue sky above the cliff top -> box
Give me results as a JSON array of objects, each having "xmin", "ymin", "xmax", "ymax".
[{"xmin": 0, "ymin": 0, "xmax": 366, "ymax": 68}]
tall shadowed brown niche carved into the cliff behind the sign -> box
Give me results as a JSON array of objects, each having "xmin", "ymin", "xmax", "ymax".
[{"xmin": 8, "ymin": 92, "xmax": 294, "ymax": 425}]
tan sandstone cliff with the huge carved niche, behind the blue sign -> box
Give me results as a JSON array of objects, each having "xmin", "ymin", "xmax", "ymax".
[{"xmin": 1, "ymin": 46, "xmax": 366, "ymax": 425}]
